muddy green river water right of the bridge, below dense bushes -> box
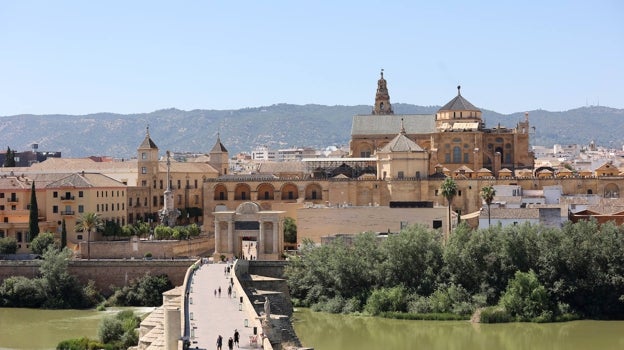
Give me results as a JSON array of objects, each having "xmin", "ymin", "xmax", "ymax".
[{"xmin": 294, "ymin": 309, "xmax": 624, "ymax": 350}]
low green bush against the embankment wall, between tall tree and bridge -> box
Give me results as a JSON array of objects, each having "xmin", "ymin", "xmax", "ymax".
[{"xmin": 108, "ymin": 273, "xmax": 173, "ymax": 306}]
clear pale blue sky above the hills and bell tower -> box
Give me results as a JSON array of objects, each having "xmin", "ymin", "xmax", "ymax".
[{"xmin": 0, "ymin": 0, "xmax": 624, "ymax": 116}]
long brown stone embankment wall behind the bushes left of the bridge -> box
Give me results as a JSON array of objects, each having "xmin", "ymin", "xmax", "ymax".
[{"xmin": 0, "ymin": 259, "xmax": 195, "ymax": 296}]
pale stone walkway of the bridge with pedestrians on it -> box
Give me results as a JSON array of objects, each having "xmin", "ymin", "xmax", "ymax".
[{"xmin": 189, "ymin": 263, "xmax": 261, "ymax": 350}]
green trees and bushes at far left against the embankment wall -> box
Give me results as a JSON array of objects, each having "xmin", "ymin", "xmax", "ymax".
[{"xmin": 0, "ymin": 248, "xmax": 101, "ymax": 309}]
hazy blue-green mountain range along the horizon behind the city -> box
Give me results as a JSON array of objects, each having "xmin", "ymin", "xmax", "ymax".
[{"xmin": 0, "ymin": 103, "xmax": 624, "ymax": 159}]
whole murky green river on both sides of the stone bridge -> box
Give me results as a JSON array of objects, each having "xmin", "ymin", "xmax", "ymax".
[{"xmin": 0, "ymin": 308, "xmax": 624, "ymax": 350}]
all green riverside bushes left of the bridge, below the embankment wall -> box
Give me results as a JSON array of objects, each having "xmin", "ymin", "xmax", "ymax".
[{"xmin": 0, "ymin": 244, "xmax": 173, "ymax": 350}]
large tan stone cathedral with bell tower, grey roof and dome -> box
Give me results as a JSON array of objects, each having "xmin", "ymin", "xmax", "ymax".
[{"xmin": 350, "ymin": 71, "xmax": 534, "ymax": 177}]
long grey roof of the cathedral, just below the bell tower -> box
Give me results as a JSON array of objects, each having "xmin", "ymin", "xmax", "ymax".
[{"xmin": 351, "ymin": 114, "xmax": 435, "ymax": 135}]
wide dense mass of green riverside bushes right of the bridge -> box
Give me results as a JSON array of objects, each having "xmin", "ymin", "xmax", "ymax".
[{"xmin": 285, "ymin": 220, "xmax": 624, "ymax": 323}]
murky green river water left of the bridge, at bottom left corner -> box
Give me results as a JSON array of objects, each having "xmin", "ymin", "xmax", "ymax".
[{"xmin": 0, "ymin": 308, "xmax": 154, "ymax": 350}]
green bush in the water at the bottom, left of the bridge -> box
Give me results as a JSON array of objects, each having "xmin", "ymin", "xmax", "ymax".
[{"xmin": 56, "ymin": 311, "xmax": 141, "ymax": 350}]
